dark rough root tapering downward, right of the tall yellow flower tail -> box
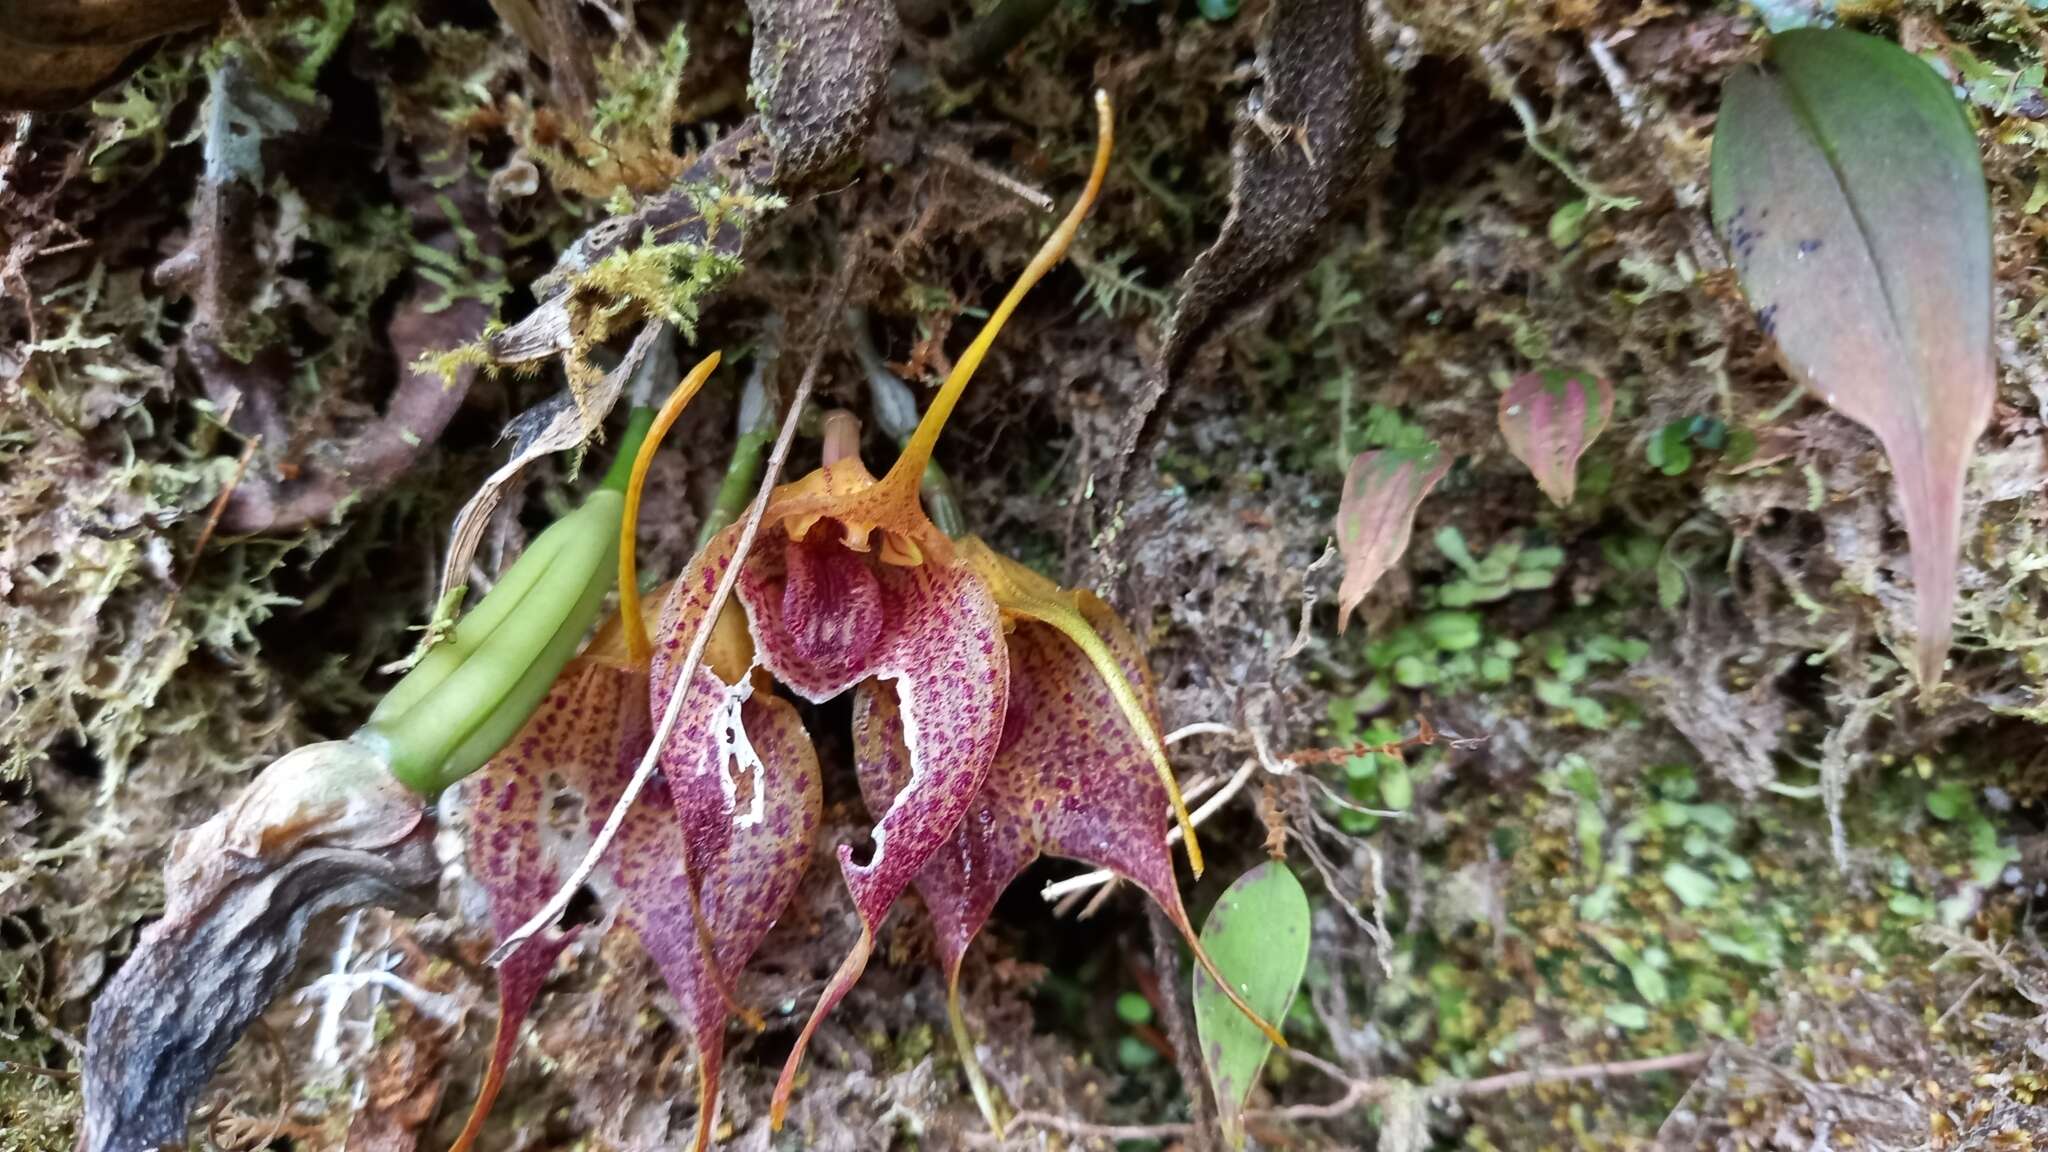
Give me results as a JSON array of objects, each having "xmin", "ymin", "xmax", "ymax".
[{"xmin": 1112, "ymin": 0, "xmax": 1386, "ymax": 498}]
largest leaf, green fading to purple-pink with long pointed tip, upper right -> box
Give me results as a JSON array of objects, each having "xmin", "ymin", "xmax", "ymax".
[{"xmin": 1712, "ymin": 29, "xmax": 1997, "ymax": 687}]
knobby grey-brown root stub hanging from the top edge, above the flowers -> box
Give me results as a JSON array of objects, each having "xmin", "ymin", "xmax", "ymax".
[{"xmin": 748, "ymin": 0, "xmax": 897, "ymax": 189}]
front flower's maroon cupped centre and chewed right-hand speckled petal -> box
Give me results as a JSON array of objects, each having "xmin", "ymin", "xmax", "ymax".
[{"xmin": 739, "ymin": 537, "xmax": 1010, "ymax": 1107}]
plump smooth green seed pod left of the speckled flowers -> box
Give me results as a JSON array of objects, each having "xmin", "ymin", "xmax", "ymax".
[{"xmin": 354, "ymin": 410, "xmax": 653, "ymax": 795}]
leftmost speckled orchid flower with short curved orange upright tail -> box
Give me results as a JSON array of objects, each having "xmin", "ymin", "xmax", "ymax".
[{"xmin": 453, "ymin": 355, "xmax": 821, "ymax": 1152}]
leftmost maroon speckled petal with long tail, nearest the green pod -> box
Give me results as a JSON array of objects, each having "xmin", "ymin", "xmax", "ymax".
[{"xmin": 453, "ymin": 660, "xmax": 622, "ymax": 1152}]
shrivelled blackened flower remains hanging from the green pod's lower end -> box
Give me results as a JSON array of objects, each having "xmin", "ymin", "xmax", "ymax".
[{"xmin": 80, "ymin": 740, "xmax": 440, "ymax": 1152}]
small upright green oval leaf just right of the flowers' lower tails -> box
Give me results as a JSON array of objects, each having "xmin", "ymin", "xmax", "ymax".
[{"xmin": 1194, "ymin": 861, "xmax": 1309, "ymax": 1148}]
